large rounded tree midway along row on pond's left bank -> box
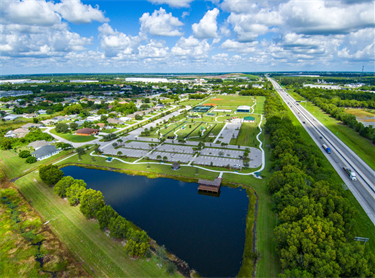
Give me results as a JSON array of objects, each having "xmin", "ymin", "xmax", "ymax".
[{"xmin": 79, "ymin": 189, "xmax": 105, "ymax": 219}]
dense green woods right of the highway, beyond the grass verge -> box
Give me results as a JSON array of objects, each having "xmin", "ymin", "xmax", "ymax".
[{"xmin": 296, "ymin": 88, "xmax": 375, "ymax": 143}]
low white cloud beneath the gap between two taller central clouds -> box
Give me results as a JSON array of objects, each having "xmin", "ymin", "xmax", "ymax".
[{"xmin": 171, "ymin": 36, "xmax": 211, "ymax": 60}]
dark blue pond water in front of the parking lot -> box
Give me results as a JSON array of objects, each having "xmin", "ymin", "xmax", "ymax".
[{"xmin": 62, "ymin": 166, "xmax": 249, "ymax": 278}]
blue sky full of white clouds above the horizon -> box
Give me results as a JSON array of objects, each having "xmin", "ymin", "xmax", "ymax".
[{"xmin": 0, "ymin": 0, "xmax": 375, "ymax": 74}]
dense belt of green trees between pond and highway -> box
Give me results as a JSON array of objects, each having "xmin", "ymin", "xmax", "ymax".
[{"xmin": 265, "ymin": 96, "xmax": 375, "ymax": 278}]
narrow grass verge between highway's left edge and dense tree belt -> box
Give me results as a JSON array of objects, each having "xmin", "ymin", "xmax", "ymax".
[{"xmin": 284, "ymin": 96, "xmax": 375, "ymax": 260}]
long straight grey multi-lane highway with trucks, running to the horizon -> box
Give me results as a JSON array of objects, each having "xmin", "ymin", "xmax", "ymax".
[{"xmin": 268, "ymin": 78, "xmax": 375, "ymax": 225}]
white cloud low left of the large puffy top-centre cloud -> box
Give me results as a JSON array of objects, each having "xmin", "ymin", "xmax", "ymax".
[{"xmin": 98, "ymin": 23, "xmax": 142, "ymax": 58}]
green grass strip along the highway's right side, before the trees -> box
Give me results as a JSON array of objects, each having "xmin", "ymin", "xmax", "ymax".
[{"xmin": 288, "ymin": 90, "xmax": 375, "ymax": 170}]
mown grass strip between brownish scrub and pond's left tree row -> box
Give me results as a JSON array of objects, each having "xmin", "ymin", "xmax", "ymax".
[{"xmin": 16, "ymin": 173, "xmax": 181, "ymax": 277}]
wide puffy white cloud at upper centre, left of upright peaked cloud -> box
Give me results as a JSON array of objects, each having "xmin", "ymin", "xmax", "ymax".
[{"xmin": 139, "ymin": 8, "xmax": 184, "ymax": 36}]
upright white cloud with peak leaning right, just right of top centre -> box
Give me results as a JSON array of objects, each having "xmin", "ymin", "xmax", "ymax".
[{"xmin": 192, "ymin": 8, "xmax": 219, "ymax": 39}]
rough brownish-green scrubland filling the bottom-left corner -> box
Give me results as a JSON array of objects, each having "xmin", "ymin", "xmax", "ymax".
[{"xmin": 0, "ymin": 182, "xmax": 90, "ymax": 277}]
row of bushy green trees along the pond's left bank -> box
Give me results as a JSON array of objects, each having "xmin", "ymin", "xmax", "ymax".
[{"xmin": 39, "ymin": 164, "xmax": 151, "ymax": 257}]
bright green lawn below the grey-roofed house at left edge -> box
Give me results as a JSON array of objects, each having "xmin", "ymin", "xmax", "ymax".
[{"xmin": 0, "ymin": 148, "xmax": 70, "ymax": 179}]
